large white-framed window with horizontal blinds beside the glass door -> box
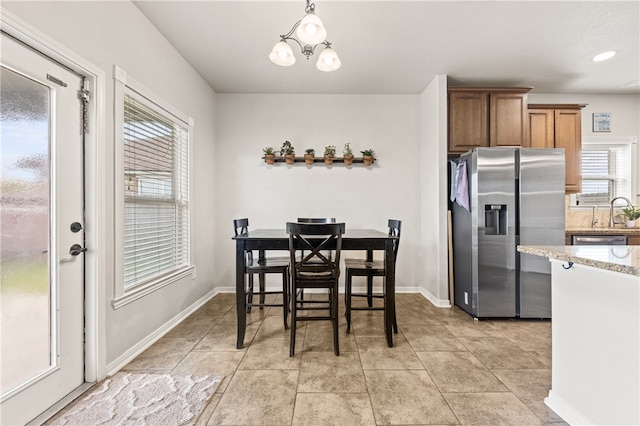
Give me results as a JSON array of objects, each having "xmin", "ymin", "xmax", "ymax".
[{"xmin": 114, "ymin": 67, "xmax": 193, "ymax": 307}]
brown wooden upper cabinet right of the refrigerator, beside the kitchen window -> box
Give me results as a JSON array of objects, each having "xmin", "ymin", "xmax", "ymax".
[{"xmin": 525, "ymin": 104, "xmax": 586, "ymax": 193}]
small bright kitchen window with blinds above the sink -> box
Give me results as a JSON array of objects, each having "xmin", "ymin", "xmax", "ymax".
[{"xmin": 572, "ymin": 138, "xmax": 636, "ymax": 206}]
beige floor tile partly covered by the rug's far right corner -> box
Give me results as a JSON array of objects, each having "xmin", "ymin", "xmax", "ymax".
[{"xmin": 171, "ymin": 351, "xmax": 244, "ymax": 392}]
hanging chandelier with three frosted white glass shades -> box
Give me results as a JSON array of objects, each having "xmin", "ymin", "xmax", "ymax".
[{"xmin": 269, "ymin": 0, "xmax": 342, "ymax": 72}]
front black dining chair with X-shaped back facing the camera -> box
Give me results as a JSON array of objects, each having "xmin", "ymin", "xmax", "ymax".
[{"xmin": 287, "ymin": 222, "xmax": 345, "ymax": 357}]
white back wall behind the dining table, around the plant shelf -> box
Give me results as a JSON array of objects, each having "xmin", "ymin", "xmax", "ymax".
[{"xmin": 213, "ymin": 94, "xmax": 424, "ymax": 291}]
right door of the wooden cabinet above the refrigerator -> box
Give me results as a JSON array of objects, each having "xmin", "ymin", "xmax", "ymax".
[{"xmin": 489, "ymin": 93, "xmax": 529, "ymax": 146}]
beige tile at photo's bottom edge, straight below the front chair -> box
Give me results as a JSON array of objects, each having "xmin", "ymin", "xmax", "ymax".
[{"xmin": 293, "ymin": 392, "xmax": 375, "ymax": 426}]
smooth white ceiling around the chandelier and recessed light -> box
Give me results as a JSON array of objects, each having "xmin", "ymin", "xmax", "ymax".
[{"xmin": 134, "ymin": 0, "xmax": 640, "ymax": 94}]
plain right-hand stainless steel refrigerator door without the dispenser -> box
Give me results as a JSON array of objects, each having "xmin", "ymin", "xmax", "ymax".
[{"xmin": 518, "ymin": 149, "xmax": 565, "ymax": 318}]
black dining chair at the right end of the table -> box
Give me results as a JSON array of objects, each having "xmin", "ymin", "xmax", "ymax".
[{"xmin": 344, "ymin": 219, "xmax": 402, "ymax": 334}]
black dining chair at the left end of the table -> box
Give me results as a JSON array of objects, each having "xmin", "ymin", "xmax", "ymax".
[{"xmin": 233, "ymin": 218, "xmax": 290, "ymax": 329}]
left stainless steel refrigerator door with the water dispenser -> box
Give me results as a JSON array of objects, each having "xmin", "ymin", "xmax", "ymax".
[{"xmin": 476, "ymin": 148, "xmax": 516, "ymax": 318}]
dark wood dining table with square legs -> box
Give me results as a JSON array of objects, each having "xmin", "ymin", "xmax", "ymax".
[{"xmin": 233, "ymin": 227, "xmax": 397, "ymax": 349}]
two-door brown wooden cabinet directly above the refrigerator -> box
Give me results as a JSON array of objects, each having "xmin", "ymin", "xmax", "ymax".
[{"xmin": 448, "ymin": 87, "xmax": 531, "ymax": 153}]
